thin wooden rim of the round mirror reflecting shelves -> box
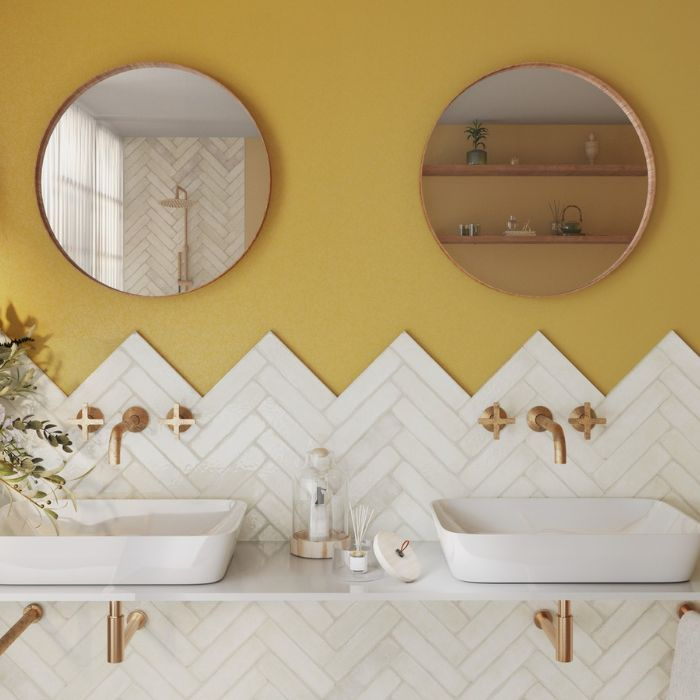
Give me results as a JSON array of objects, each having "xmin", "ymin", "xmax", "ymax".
[{"xmin": 419, "ymin": 61, "xmax": 656, "ymax": 298}]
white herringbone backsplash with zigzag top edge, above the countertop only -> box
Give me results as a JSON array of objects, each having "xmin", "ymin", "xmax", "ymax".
[{"xmin": 6, "ymin": 332, "xmax": 700, "ymax": 540}]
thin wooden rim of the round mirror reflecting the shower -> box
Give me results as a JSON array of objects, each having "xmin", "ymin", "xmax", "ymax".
[{"xmin": 34, "ymin": 61, "xmax": 272, "ymax": 299}]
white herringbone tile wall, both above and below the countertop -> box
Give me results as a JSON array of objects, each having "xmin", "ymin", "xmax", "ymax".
[{"xmin": 0, "ymin": 333, "xmax": 700, "ymax": 700}]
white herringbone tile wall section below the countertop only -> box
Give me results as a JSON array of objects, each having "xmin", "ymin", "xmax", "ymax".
[{"xmin": 0, "ymin": 601, "xmax": 678, "ymax": 700}]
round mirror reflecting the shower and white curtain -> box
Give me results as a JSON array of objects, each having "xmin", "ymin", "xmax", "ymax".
[{"xmin": 37, "ymin": 64, "xmax": 270, "ymax": 296}]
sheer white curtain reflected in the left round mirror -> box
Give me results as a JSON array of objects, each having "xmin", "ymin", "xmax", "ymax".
[{"xmin": 41, "ymin": 105, "xmax": 124, "ymax": 289}]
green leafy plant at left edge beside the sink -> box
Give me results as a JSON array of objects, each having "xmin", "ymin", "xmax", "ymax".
[{"xmin": 0, "ymin": 338, "xmax": 72, "ymax": 520}]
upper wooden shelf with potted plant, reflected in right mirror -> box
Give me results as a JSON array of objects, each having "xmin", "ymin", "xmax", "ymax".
[{"xmin": 423, "ymin": 163, "xmax": 647, "ymax": 177}]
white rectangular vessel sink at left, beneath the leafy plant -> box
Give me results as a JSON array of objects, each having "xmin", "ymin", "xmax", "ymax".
[{"xmin": 0, "ymin": 500, "xmax": 246, "ymax": 585}]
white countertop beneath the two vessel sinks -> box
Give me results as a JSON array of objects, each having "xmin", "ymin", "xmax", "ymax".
[{"xmin": 0, "ymin": 542, "xmax": 700, "ymax": 602}]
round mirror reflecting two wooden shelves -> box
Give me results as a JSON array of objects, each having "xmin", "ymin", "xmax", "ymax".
[{"xmin": 421, "ymin": 64, "xmax": 655, "ymax": 296}]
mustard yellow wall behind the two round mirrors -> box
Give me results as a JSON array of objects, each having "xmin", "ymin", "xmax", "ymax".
[{"xmin": 0, "ymin": 0, "xmax": 700, "ymax": 390}]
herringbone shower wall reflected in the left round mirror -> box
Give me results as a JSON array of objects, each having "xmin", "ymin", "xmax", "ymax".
[{"xmin": 124, "ymin": 137, "xmax": 245, "ymax": 295}]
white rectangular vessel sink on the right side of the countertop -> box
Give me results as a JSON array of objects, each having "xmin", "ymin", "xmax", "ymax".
[{"xmin": 432, "ymin": 498, "xmax": 700, "ymax": 583}]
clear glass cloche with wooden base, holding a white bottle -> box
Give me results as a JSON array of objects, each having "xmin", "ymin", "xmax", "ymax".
[{"xmin": 290, "ymin": 447, "xmax": 349, "ymax": 559}]
